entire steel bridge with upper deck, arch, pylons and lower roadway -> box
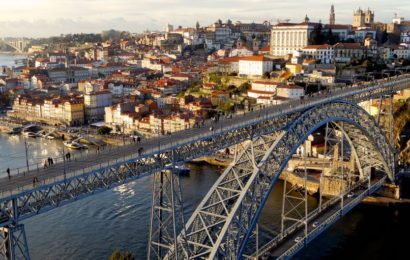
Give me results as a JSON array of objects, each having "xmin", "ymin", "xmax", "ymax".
[{"xmin": 0, "ymin": 73, "xmax": 410, "ymax": 259}]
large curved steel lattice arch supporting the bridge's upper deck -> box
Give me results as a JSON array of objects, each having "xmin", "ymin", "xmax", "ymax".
[{"xmin": 167, "ymin": 101, "xmax": 395, "ymax": 259}]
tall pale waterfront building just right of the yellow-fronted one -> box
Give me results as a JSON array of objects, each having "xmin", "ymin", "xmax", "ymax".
[{"xmin": 84, "ymin": 91, "xmax": 112, "ymax": 123}]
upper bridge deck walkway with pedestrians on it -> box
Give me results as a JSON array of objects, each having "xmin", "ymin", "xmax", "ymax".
[{"xmin": 0, "ymin": 75, "xmax": 410, "ymax": 199}]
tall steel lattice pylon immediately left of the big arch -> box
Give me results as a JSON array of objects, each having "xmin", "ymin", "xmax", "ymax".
[{"xmin": 147, "ymin": 151, "xmax": 185, "ymax": 259}]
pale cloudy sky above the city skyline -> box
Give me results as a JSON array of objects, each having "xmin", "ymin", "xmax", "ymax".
[{"xmin": 0, "ymin": 0, "xmax": 410, "ymax": 37}]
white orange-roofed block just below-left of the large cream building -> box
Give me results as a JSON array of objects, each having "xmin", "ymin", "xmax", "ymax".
[{"xmin": 239, "ymin": 55, "xmax": 273, "ymax": 76}]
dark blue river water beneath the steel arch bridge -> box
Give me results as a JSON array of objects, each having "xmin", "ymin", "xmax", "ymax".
[{"xmin": 0, "ymin": 135, "xmax": 410, "ymax": 260}]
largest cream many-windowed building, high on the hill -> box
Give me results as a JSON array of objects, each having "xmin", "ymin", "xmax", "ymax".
[{"xmin": 270, "ymin": 19, "xmax": 315, "ymax": 57}]
